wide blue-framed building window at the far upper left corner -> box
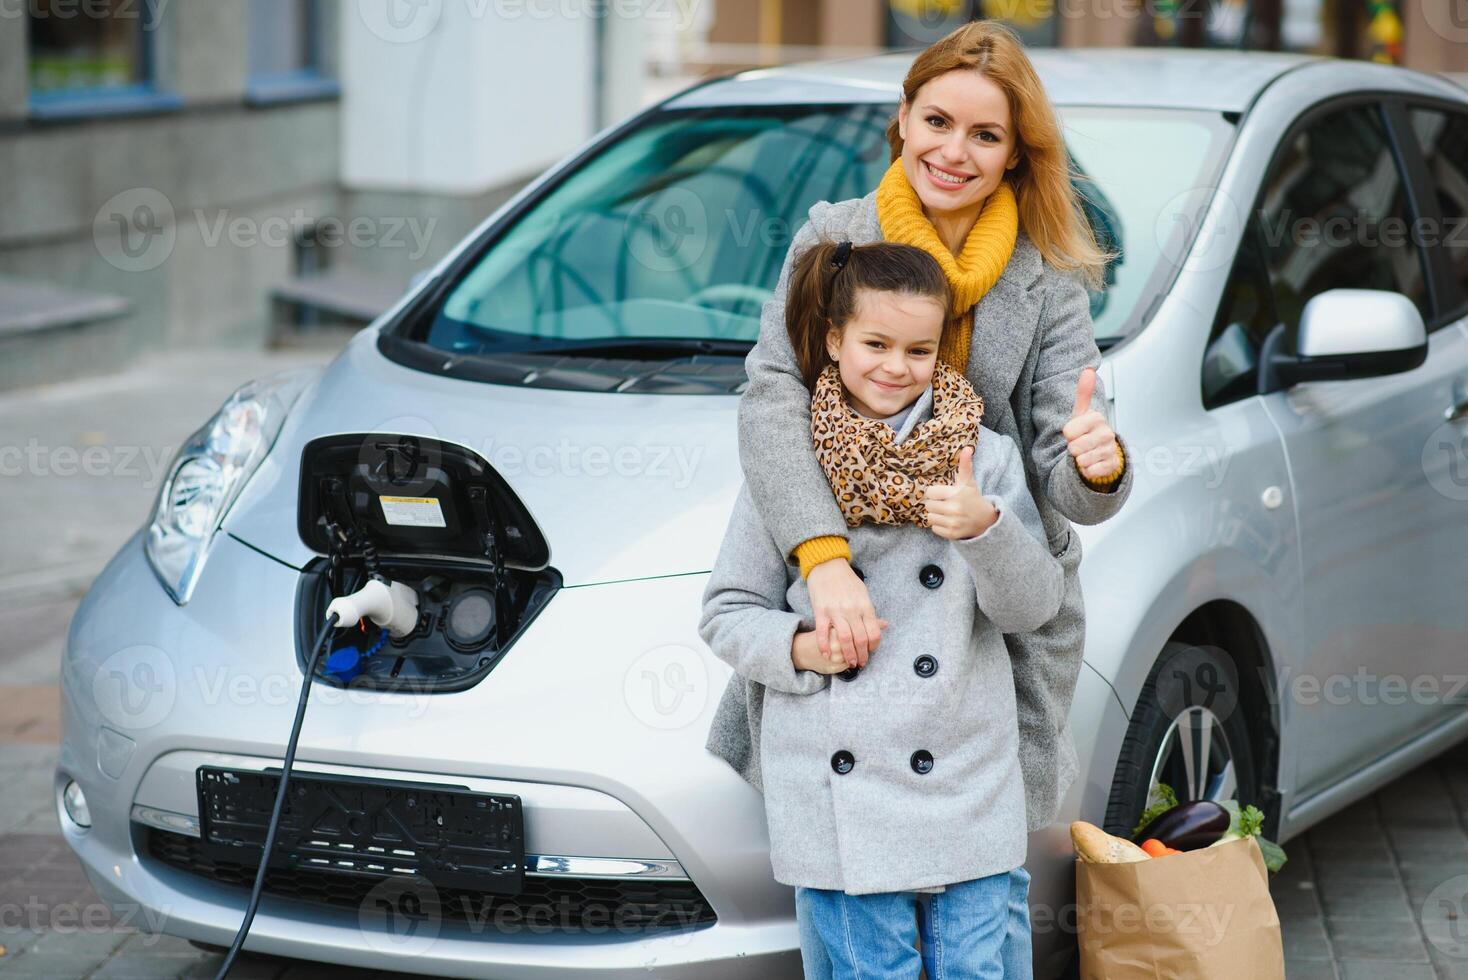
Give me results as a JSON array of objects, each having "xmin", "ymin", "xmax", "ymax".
[{"xmin": 26, "ymin": 0, "xmax": 176, "ymax": 114}]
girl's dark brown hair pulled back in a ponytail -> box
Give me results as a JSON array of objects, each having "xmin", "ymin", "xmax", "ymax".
[{"xmin": 785, "ymin": 239, "xmax": 953, "ymax": 390}]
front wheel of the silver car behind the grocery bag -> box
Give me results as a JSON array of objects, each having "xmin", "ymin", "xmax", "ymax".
[{"xmin": 1104, "ymin": 643, "xmax": 1258, "ymax": 838}]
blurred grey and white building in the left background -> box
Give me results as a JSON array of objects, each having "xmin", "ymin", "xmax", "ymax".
[{"xmin": 0, "ymin": 0, "xmax": 660, "ymax": 390}]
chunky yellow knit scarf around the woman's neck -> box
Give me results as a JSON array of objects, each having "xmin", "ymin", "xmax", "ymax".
[{"xmin": 876, "ymin": 157, "xmax": 1019, "ymax": 373}]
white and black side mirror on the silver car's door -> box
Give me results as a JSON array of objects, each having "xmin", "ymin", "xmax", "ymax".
[{"xmin": 1258, "ymin": 289, "xmax": 1427, "ymax": 395}]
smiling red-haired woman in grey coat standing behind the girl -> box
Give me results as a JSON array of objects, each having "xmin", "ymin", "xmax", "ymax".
[{"xmin": 708, "ymin": 21, "xmax": 1132, "ymax": 968}]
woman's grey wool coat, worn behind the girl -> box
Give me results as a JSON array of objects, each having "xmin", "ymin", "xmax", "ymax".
[{"xmin": 706, "ymin": 189, "xmax": 1136, "ymax": 830}]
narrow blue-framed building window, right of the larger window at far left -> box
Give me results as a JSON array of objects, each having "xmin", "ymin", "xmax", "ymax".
[{"xmin": 247, "ymin": 0, "xmax": 338, "ymax": 101}]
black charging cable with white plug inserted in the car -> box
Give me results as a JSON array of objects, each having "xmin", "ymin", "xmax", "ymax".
[{"xmin": 214, "ymin": 578, "xmax": 418, "ymax": 980}]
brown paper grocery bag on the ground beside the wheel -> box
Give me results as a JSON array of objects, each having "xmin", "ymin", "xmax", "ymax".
[{"xmin": 1076, "ymin": 838, "xmax": 1285, "ymax": 980}]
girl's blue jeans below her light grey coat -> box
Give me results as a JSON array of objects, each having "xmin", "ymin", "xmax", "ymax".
[{"xmin": 796, "ymin": 867, "xmax": 1033, "ymax": 980}]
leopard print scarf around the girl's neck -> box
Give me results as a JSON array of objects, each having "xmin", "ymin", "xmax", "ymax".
[{"xmin": 810, "ymin": 361, "xmax": 984, "ymax": 527}]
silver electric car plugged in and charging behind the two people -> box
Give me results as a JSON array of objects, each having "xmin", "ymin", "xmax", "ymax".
[{"xmin": 54, "ymin": 50, "xmax": 1468, "ymax": 977}]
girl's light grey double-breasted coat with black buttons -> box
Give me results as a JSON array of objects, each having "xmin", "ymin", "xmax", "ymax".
[{"xmin": 699, "ymin": 386, "xmax": 1064, "ymax": 895}]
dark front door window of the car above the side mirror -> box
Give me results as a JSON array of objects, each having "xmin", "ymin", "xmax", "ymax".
[{"xmin": 1252, "ymin": 104, "xmax": 1431, "ymax": 334}]
